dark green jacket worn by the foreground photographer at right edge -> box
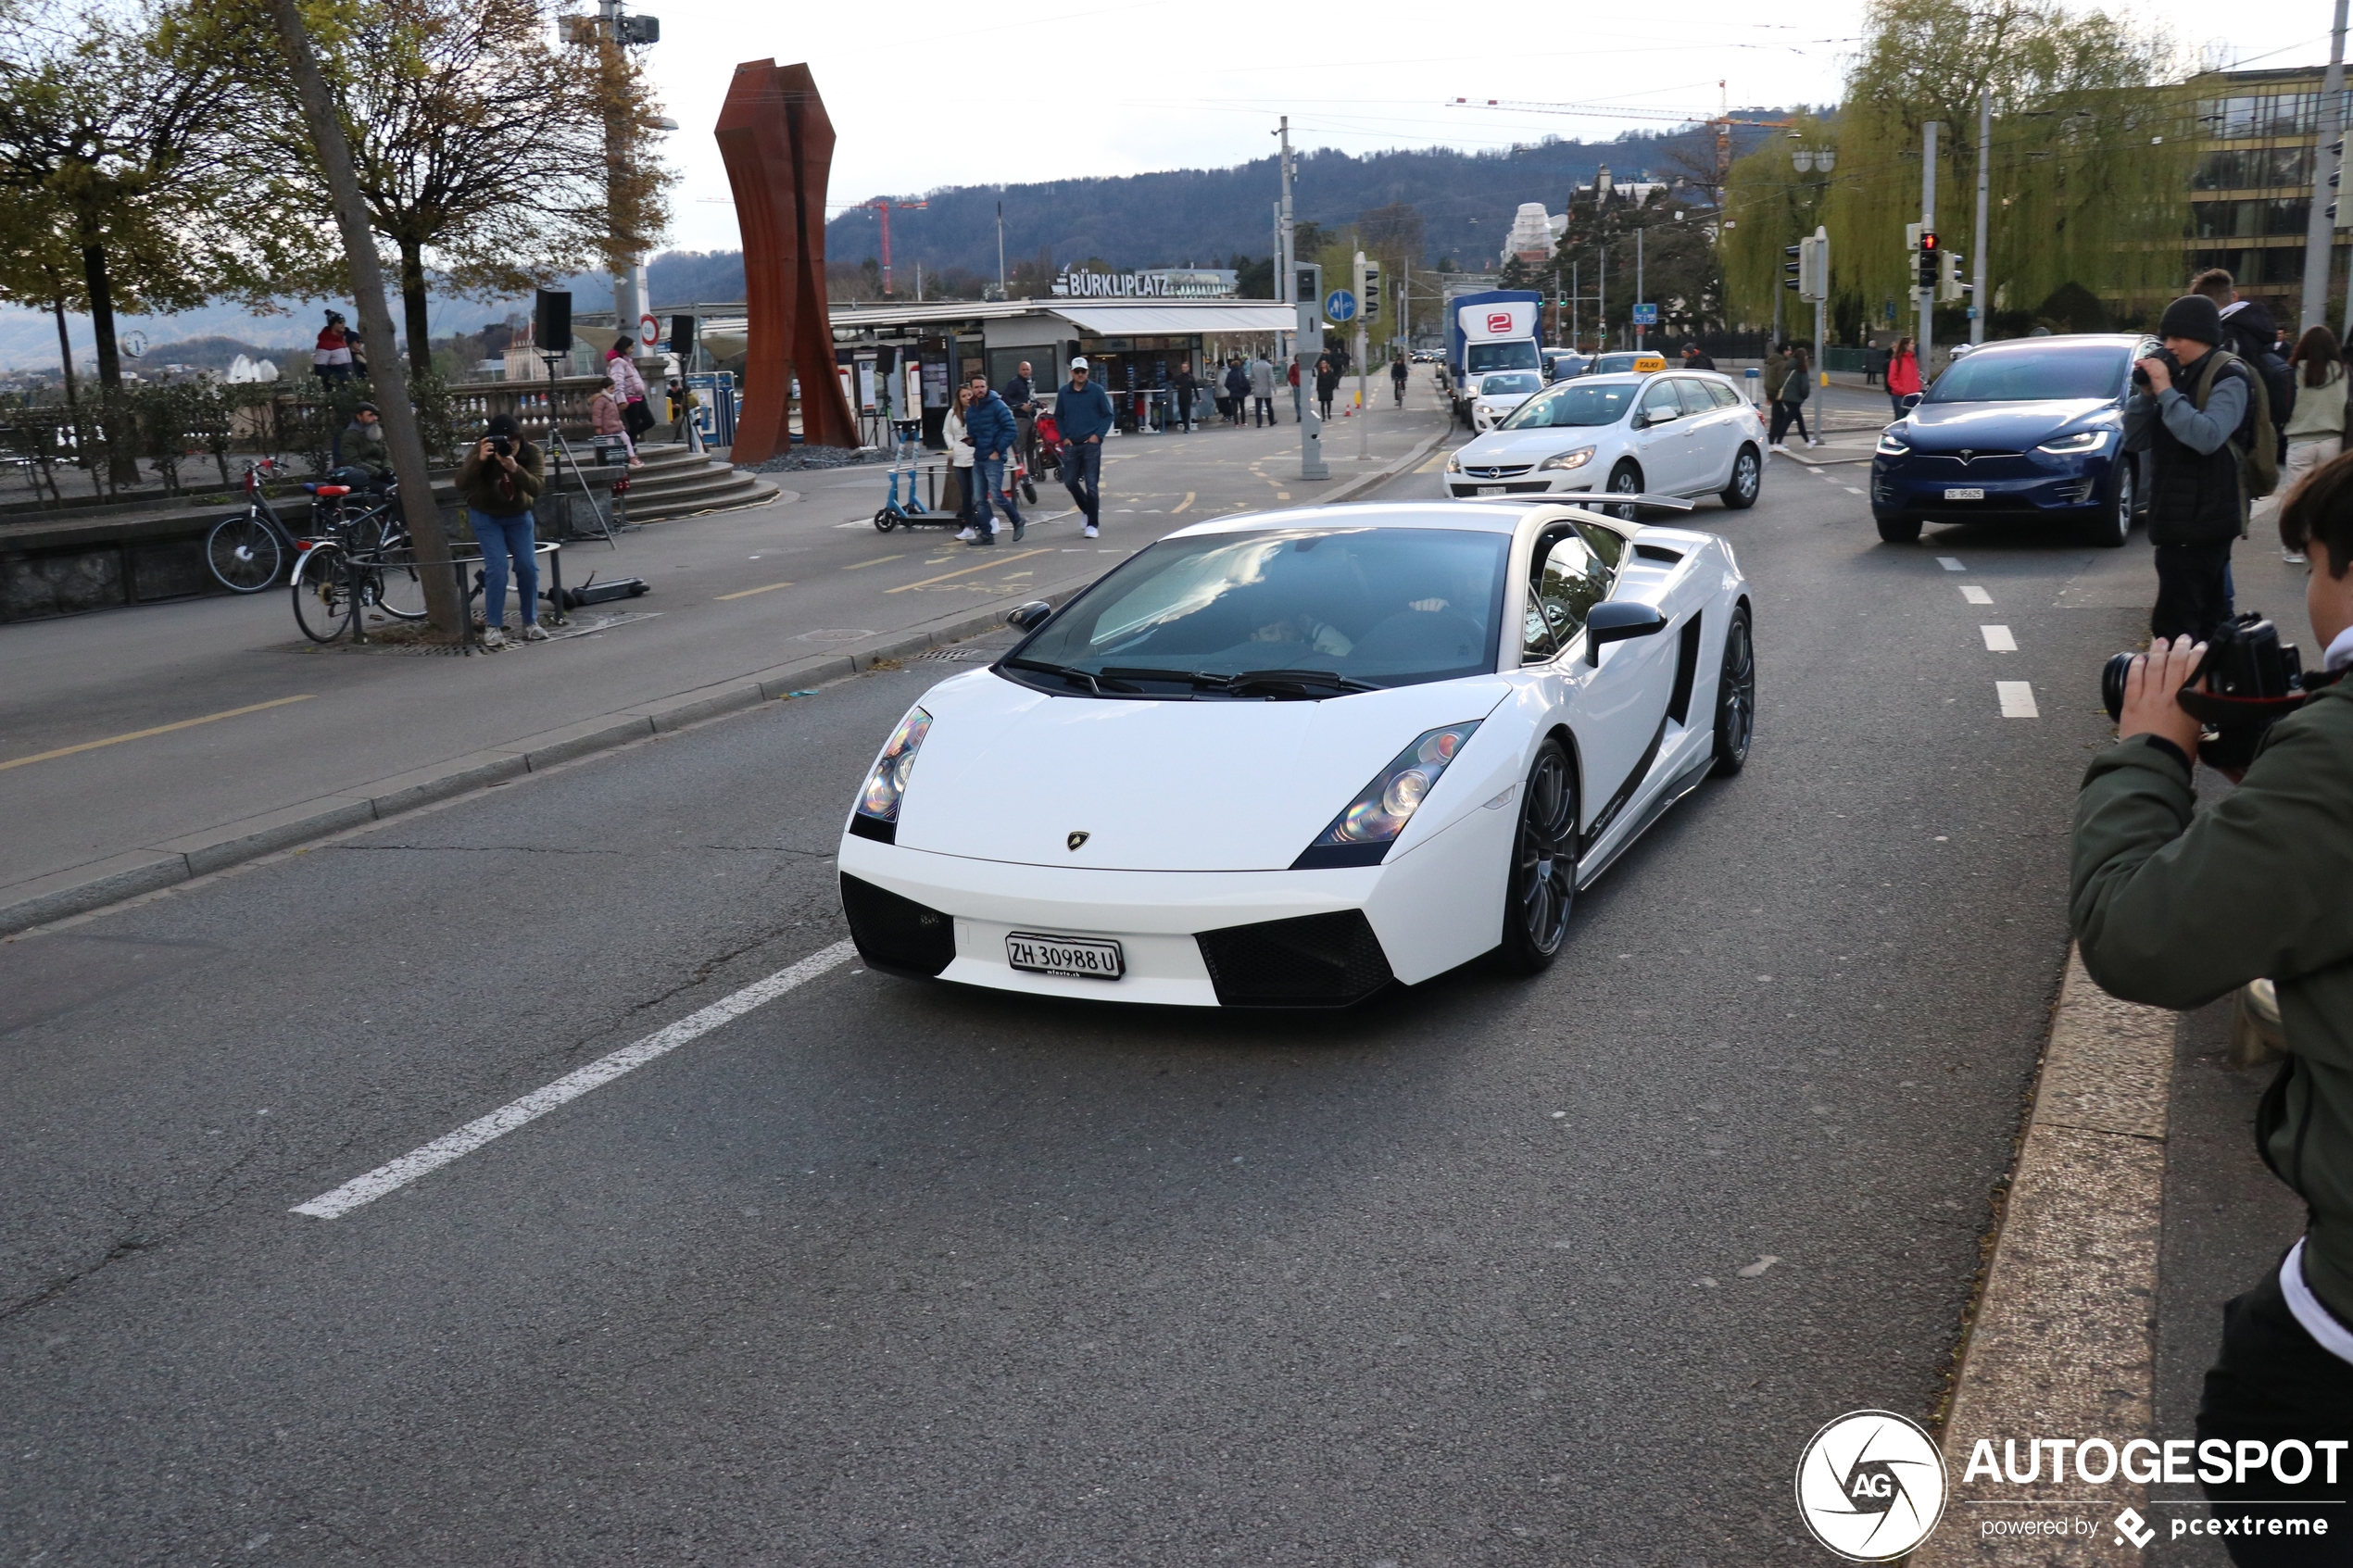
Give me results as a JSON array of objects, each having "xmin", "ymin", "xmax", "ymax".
[{"xmin": 2069, "ymin": 680, "xmax": 2353, "ymax": 1323}]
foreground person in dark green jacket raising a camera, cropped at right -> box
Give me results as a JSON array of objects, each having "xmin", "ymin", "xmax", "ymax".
[{"xmin": 2069, "ymin": 460, "xmax": 2353, "ymax": 1568}]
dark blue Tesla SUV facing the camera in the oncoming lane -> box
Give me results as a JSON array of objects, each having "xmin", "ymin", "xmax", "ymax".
[{"xmin": 1870, "ymin": 333, "xmax": 2156, "ymax": 546}]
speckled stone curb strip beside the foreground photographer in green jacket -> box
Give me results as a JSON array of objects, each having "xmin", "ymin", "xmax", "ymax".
[{"xmin": 1908, "ymin": 945, "xmax": 2179, "ymax": 1568}]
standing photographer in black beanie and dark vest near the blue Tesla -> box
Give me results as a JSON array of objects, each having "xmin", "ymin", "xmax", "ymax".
[{"xmin": 2125, "ymin": 294, "xmax": 2254, "ymax": 637}]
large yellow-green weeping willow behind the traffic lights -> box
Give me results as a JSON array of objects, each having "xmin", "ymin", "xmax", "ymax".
[{"xmin": 1824, "ymin": 0, "xmax": 2197, "ymax": 335}]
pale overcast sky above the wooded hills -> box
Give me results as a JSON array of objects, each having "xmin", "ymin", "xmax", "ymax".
[{"xmin": 635, "ymin": 0, "xmax": 2330, "ymax": 252}]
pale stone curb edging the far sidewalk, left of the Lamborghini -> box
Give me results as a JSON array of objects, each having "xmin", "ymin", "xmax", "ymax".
[{"xmin": 0, "ymin": 430, "xmax": 1447, "ymax": 935}]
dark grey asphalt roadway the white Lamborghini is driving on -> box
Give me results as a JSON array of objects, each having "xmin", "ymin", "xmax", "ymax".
[{"xmin": 0, "ymin": 434, "xmax": 2240, "ymax": 1568}]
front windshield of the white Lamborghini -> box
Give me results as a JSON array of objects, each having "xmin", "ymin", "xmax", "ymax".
[{"xmin": 1000, "ymin": 527, "xmax": 1511, "ymax": 700}]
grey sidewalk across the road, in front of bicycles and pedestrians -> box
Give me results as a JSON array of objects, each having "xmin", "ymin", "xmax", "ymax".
[{"xmin": 0, "ymin": 407, "xmax": 1447, "ymax": 934}]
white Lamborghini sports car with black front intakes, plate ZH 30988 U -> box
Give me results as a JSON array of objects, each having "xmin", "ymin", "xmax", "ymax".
[{"xmin": 840, "ymin": 501, "xmax": 1755, "ymax": 1006}]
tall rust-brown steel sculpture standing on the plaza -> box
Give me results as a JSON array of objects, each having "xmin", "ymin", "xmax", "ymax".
[{"xmin": 718, "ymin": 58, "xmax": 859, "ymax": 463}]
